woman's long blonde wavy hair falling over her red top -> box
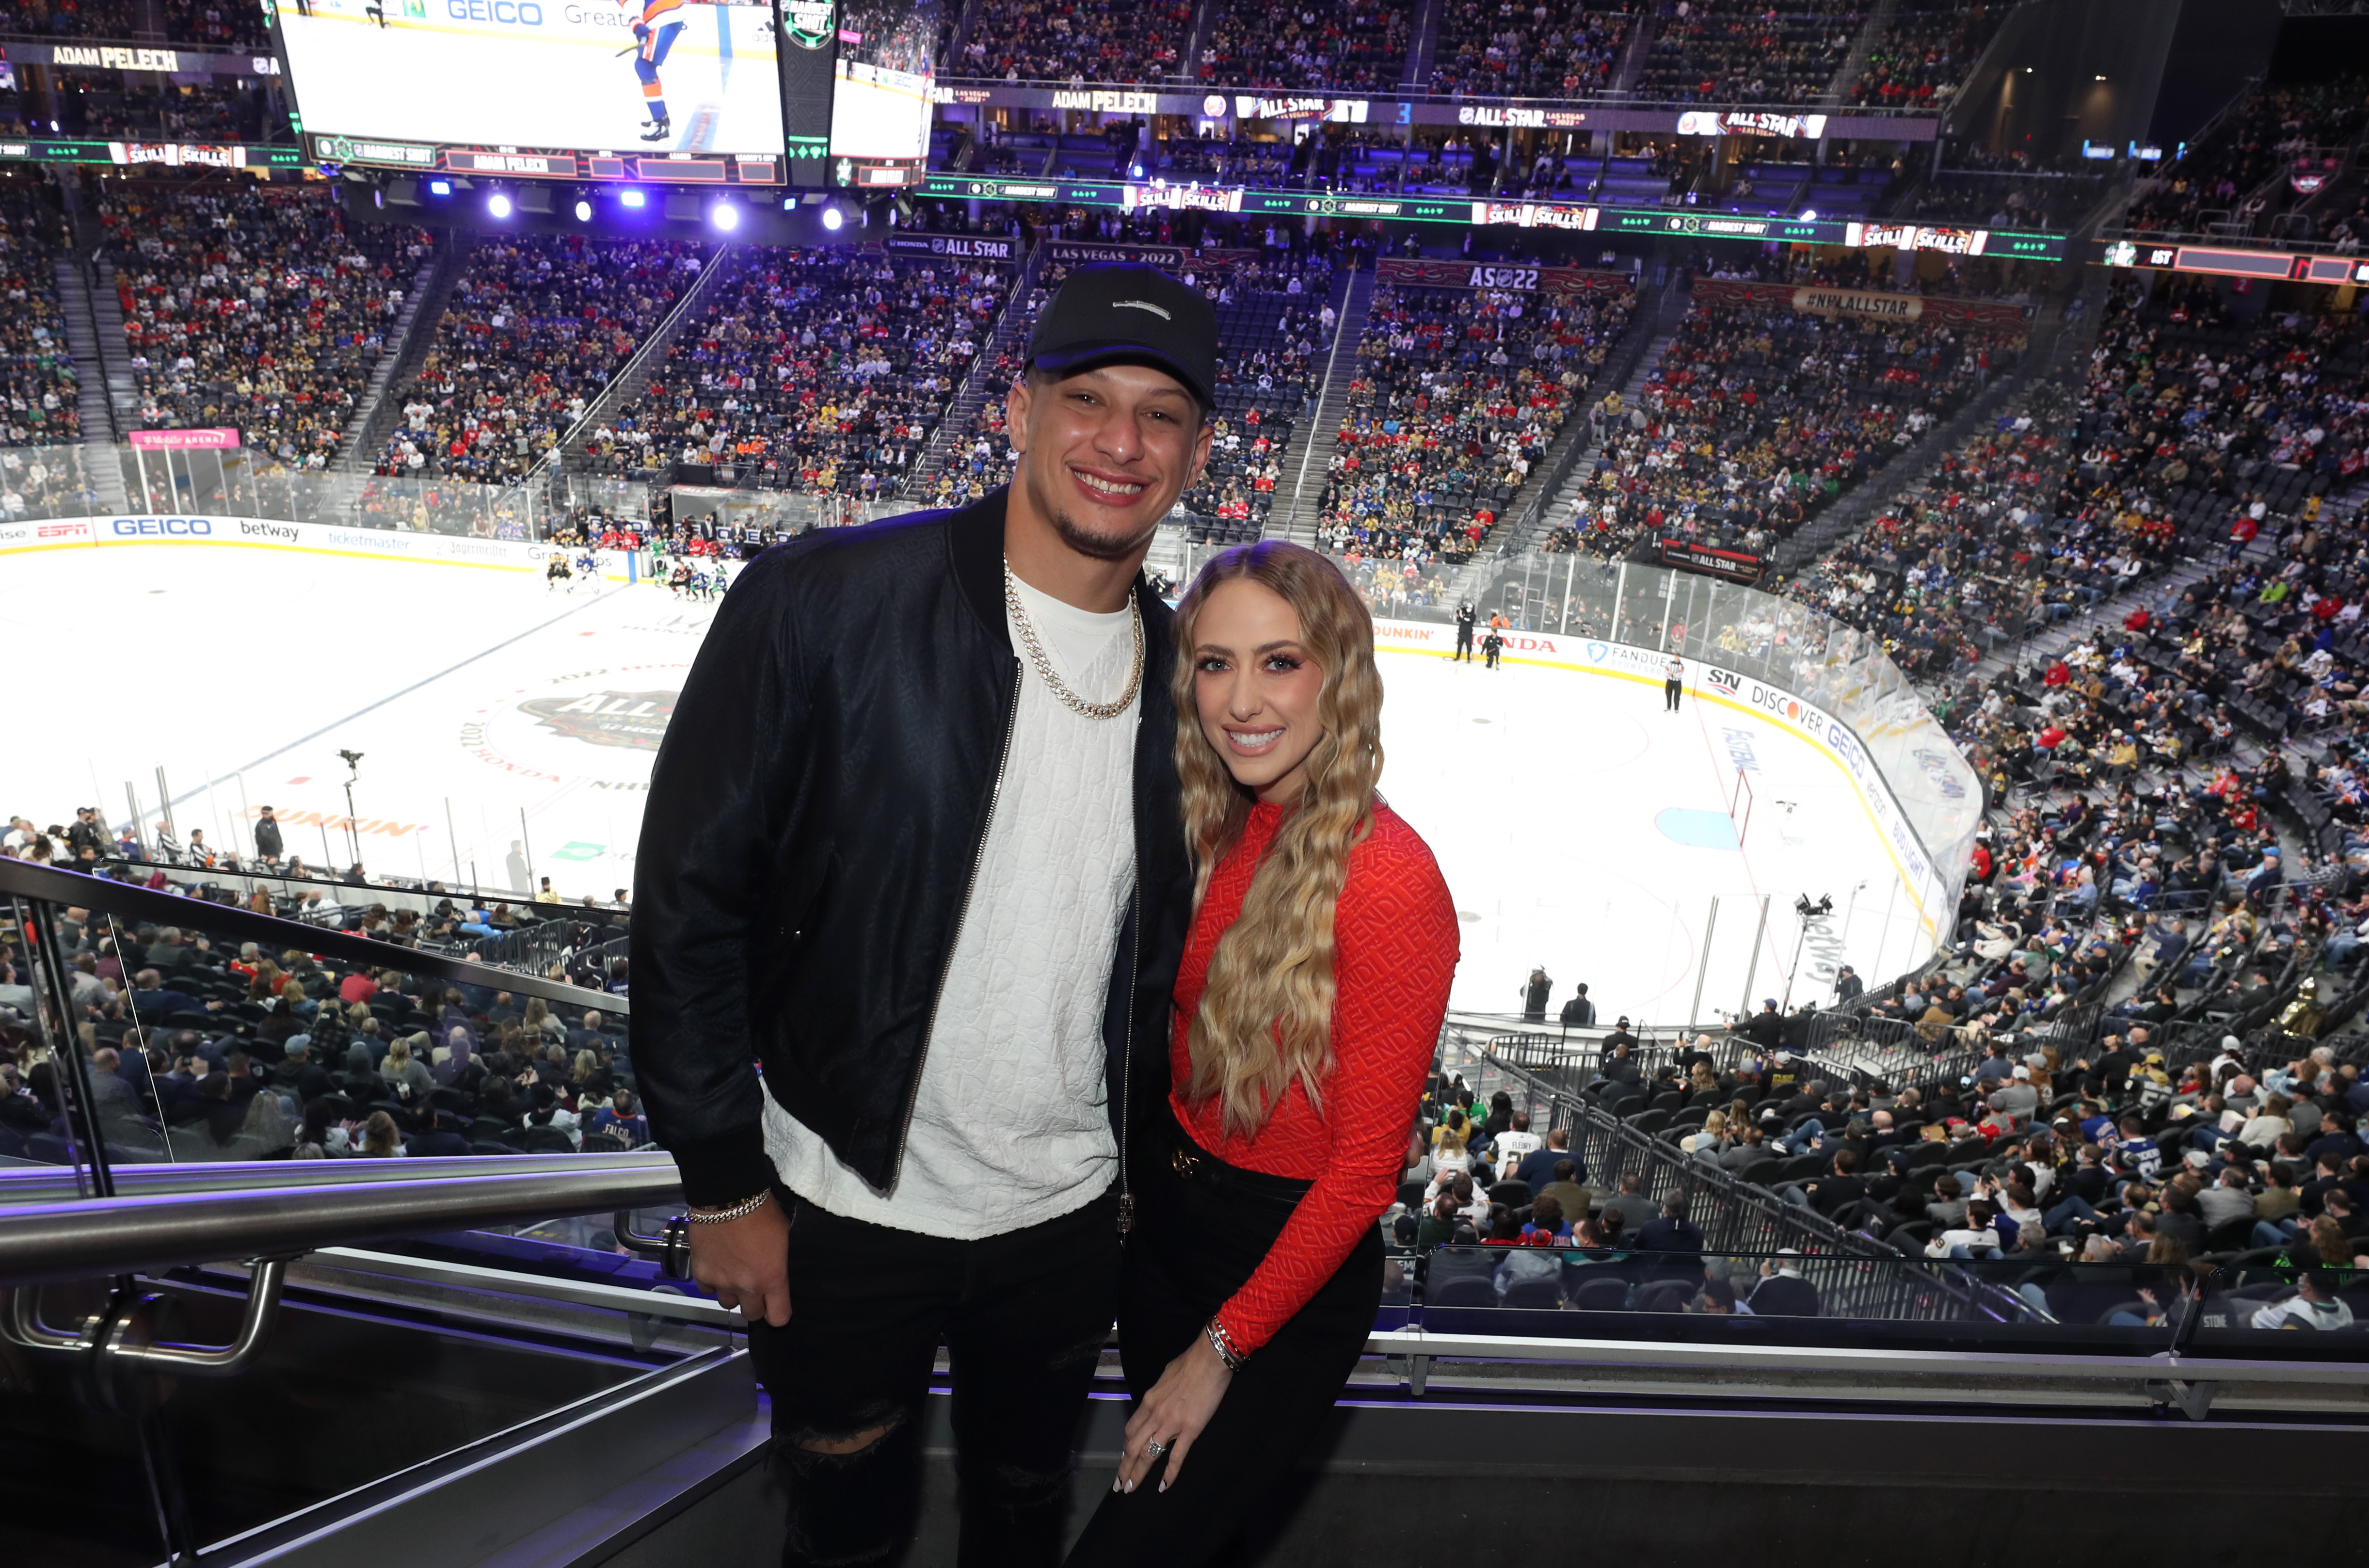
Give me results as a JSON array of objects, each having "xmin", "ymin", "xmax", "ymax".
[{"xmin": 1175, "ymin": 543, "xmax": 1381, "ymax": 1137}]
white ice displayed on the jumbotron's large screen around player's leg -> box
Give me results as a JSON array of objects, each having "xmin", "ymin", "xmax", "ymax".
[{"xmin": 280, "ymin": 0, "xmax": 782, "ymax": 156}]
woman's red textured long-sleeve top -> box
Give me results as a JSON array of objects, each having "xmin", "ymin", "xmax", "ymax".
[{"xmin": 1168, "ymin": 800, "xmax": 1457, "ymax": 1350}]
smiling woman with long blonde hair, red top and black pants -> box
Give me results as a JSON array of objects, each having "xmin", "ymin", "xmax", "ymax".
[{"xmin": 1069, "ymin": 543, "xmax": 1457, "ymax": 1568}]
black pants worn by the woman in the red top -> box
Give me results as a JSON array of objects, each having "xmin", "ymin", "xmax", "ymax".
[{"xmin": 1069, "ymin": 1125, "xmax": 1381, "ymax": 1568}]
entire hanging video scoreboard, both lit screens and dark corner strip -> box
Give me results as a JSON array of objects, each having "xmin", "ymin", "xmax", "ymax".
[{"xmin": 272, "ymin": 0, "xmax": 938, "ymax": 187}]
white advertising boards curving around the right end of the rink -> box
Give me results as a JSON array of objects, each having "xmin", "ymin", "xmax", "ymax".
[{"xmin": 1374, "ymin": 621, "xmax": 1964, "ymax": 933}]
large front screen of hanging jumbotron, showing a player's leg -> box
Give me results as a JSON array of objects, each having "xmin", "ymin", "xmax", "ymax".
[{"xmin": 277, "ymin": 0, "xmax": 782, "ymax": 180}]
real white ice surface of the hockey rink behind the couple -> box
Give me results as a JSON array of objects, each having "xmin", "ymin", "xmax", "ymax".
[{"xmin": 0, "ymin": 545, "xmax": 1931, "ymax": 1023}]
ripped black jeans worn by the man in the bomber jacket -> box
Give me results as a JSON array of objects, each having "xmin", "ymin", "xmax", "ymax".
[{"xmin": 749, "ymin": 1186, "xmax": 1120, "ymax": 1568}]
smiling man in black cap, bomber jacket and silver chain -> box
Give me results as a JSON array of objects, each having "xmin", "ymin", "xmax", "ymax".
[{"xmin": 633, "ymin": 265, "xmax": 1217, "ymax": 1563}]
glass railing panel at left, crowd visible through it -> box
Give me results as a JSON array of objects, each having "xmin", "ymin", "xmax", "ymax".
[{"xmin": 0, "ymin": 862, "xmax": 649, "ymax": 1191}]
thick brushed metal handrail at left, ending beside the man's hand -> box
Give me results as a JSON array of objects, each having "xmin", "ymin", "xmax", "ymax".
[{"xmin": 0, "ymin": 1153, "xmax": 682, "ymax": 1289}]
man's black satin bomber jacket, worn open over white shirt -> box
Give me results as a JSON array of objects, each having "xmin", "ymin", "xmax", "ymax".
[{"xmin": 633, "ymin": 490, "xmax": 1192, "ymax": 1206}]
